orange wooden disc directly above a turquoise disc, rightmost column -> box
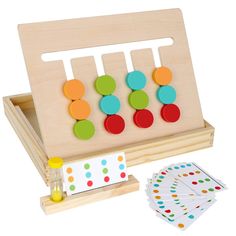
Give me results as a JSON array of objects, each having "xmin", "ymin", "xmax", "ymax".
[{"xmin": 152, "ymin": 66, "xmax": 172, "ymax": 85}]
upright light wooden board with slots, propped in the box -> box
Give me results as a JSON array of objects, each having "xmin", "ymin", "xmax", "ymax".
[{"xmin": 19, "ymin": 9, "xmax": 204, "ymax": 158}]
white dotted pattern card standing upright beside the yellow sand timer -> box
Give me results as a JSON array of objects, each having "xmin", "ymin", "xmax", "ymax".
[{"xmin": 63, "ymin": 152, "xmax": 128, "ymax": 195}]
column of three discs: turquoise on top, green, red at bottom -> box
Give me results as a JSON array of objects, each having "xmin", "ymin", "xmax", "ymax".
[{"xmin": 126, "ymin": 70, "xmax": 154, "ymax": 128}]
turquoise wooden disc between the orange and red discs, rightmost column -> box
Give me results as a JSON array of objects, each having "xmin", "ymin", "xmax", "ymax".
[{"xmin": 156, "ymin": 85, "xmax": 176, "ymax": 104}]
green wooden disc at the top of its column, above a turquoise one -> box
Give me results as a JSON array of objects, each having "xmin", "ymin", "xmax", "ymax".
[{"xmin": 95, "ymin": 75, "xmax": 116, "ymax": 95}]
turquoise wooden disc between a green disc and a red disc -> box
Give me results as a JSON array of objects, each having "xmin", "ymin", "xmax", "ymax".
[{"xmin": 99, "ymin": 95, "xmax": 120, "ymax": 115}]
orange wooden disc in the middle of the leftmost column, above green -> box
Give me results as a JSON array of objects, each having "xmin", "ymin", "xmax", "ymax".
[{"xmin": 69, "ymin": 99, "xmax": 91, "ymax": 120}]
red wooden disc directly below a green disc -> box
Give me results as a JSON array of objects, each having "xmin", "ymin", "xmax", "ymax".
[{"xmin": 133, "ymin": 109, "xmax": 154, "ymax": 128}]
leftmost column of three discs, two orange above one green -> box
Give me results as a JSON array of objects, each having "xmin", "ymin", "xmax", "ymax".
[{"xmin": 63, "ymin": 79, "xmax": 95, "ymax": 140}]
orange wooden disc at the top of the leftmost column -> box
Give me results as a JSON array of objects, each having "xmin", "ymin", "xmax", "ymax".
[{"xmin": 63, "ymin": 79, "xmax": 85, "ymax": 100}]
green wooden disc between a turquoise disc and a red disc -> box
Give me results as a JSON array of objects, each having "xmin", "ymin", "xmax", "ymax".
[{"xmin": 129, "ymin": 90, "xmax": 149, "ymax": 110}]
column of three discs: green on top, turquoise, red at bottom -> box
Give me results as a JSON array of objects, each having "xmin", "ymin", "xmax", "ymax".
[{"xmin": 95, "ymin": 75, "xmax": 125, "ymax": 134}]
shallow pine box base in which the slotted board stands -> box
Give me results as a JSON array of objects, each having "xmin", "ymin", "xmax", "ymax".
[{"xmin": 3, "ymin": 94, "xmax": 214, "ymax": 185}]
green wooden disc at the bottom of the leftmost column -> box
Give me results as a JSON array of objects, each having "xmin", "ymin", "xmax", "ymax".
[{"xmin": 73, "ymin": 120, "xmax": 95, "ymax": 140}]
